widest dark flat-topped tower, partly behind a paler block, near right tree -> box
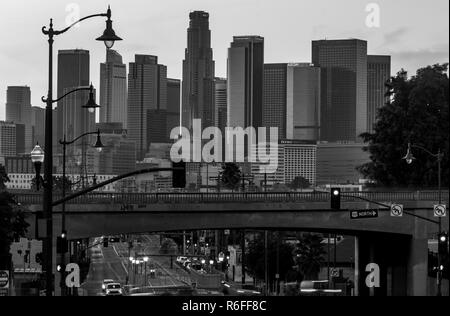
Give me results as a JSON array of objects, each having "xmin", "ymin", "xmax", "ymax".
[{"xmin": 312, "ymin": 39, "xmax": 367, "ymax": 142}]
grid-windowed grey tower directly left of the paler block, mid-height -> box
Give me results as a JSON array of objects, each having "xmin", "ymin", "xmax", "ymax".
[{"xmin": 263, "ymin": 64, "xmax": 287, "ymax": 139}]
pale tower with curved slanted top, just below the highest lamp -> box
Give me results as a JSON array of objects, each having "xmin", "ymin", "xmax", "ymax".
[{"xmin": 100, "ymin": 49, "xmax": 127, "ymax": 129}]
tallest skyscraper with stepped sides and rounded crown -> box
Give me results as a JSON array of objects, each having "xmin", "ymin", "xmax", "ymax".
[{"xmin": 182, "ymin": 11, "xmax": 215, "ymax": 129}]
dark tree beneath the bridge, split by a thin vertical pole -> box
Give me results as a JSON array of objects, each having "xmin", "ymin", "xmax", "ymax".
[{"xmin": 245, "ymin": 234, "xmax": 295, "ymax": 283}]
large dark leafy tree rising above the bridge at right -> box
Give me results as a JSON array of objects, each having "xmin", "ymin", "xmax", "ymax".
[{"xmin": 358, "ymin": 64, "xmax": 449, "ymax": 187}]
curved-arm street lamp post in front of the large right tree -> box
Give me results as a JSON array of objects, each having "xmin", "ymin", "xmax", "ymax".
[{"xmin": 403, "ymin": 143, "xmax": 444, "ymax": 296}]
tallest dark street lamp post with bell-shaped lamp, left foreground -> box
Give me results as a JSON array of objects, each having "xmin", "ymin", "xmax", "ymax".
[{"xmin": 42, "ymin": 8, "xmax": 121, "ymax": 296}]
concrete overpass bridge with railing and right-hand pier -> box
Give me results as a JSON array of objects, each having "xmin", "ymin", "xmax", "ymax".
[{"xmin": 16, "ymin": 191, "xmax": 448, "ymax": 295}]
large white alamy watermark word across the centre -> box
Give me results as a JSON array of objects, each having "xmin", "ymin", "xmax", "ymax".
[{"xmin": 170, "ymin": 119, "xmax": 279, "ymax": 173}]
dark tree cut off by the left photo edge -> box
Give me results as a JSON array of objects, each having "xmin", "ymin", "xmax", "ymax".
[{"xmin": 0, "ymin": 166, "xmax": 29, "ymax": 269}]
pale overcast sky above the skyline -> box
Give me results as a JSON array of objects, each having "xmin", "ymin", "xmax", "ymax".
[{"xmin": 0, "ymin": 0, "xmax": 449, "ymax": 120}]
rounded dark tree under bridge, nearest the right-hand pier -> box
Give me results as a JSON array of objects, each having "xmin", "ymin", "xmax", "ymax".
[{"xmin": 296, "ymin": 233, "xmax": 325, "ymax": 280}]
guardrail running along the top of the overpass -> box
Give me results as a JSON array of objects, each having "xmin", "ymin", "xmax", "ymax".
[{"xmin": 15, "ymin": 191, "xmax": 449, "ymax": 205}]
